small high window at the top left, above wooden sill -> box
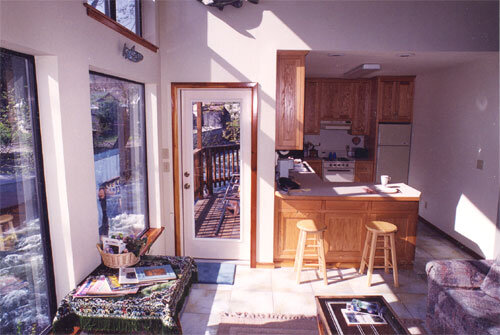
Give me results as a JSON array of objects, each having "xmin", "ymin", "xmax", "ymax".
[{"xmin": 87, "ymin": 0, "xmax": 142, "ymax": 36}]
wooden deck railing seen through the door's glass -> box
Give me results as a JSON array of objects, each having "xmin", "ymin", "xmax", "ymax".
[{"xmin": 193, "ymin": 144, "xmax": 240, "ymax": 199}]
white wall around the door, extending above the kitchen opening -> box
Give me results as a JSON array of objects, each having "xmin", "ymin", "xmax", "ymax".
[{"xmin": 159, "ymin": 0, "xmax": 498, "ymax": 262}]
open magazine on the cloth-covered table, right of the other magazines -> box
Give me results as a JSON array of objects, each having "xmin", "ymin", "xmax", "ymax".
[{"xmin": 118, "ymin": 264, "xmax": 177, "ymax": 285}]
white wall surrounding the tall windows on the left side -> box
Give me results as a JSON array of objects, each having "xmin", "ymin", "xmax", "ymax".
[{"xmin": 0, "ymin": 0, "xmax": 164, "ymax": 300}]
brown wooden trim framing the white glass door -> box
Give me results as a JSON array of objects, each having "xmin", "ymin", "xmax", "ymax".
[{"xmin": 171, "ymin": 83, "xmax": 259, "ymax": 268}]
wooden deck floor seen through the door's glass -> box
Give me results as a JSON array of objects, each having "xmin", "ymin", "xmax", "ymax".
[{"xmin": 194, "ymin": 193, "xmax": 240, "ymax": 239}]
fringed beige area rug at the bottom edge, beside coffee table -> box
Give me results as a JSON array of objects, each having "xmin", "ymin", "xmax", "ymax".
[{"xmin": 217, "ymin": 313, "xmax": 318, "ymax": 335}]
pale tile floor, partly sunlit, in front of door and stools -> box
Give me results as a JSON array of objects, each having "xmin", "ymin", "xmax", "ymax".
[{"xmin": 181, "ymin": 223, "xmax": 472, "ymax": 335}]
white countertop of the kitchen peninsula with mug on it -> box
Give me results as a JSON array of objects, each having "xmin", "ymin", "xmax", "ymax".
[{"xmin": 276, "ymin": 167, "xmax": 421, "ymax": 201}]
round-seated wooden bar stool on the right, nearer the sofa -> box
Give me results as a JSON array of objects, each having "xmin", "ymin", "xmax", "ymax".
[{"xmin": 359, "ymin": 221, "xmax": 399, "ymax": 287}]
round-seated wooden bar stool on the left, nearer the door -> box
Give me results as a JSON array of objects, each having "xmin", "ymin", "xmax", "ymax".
[{"xmin": 293, "ymin": 219, "xmax": 328, "ymax": 285}]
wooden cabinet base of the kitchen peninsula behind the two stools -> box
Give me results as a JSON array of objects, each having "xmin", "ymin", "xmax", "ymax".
[{"xmin": 274, "ymin": 196, "xmax": 418, "ymax": 267}]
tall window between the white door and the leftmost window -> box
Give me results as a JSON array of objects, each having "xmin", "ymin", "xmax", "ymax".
[{"xmin": 90, "ymin": 72, "xmax": 149, "ymax": 236}]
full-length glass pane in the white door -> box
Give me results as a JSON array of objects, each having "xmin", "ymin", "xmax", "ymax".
[{"xmin": 192, "ymin": 102, "xmax": 241, "ymax": 239}]
